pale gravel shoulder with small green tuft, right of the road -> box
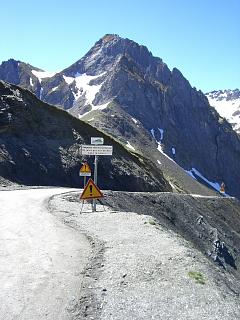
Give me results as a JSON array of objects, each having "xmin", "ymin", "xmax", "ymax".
[{"xmin": 49, "ymin": 194, "xmax": 240, "ymax": 320}]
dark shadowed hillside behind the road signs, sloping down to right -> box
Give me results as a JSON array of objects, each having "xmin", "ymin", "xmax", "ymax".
[{"xmin": 0, "ymin": 81, "xmax": 171, "ymax": 191}]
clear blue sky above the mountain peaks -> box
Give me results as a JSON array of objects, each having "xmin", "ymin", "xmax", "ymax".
[{"xmin": 0, "ymin": 0, "xmax": 240, "ymax": 92}]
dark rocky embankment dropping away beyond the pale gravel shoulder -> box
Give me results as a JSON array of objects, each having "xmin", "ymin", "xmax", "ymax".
[{"xmin": 103, "ymin": 192, "xmax": 240, "ymax": 278}]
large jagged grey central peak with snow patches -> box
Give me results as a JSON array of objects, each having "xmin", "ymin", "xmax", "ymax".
[{"xmin": 1, "ymin": 35, "xmax": 240, "ymax": 196}]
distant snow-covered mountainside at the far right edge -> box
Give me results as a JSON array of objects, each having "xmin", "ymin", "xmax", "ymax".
[{"xmin": 206, "ymin": 89, "xmax": 240, "ymax": 134}]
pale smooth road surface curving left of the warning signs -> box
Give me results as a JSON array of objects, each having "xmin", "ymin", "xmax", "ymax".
[{"xmin": 0, "ymin": 188, "xmax": 91, "ymax": 320}]
